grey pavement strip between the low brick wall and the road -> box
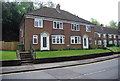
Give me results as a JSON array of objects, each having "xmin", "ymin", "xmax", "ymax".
[{"xmin": 0, "ymin": 54, "xmax": 120, "ymax": 74}]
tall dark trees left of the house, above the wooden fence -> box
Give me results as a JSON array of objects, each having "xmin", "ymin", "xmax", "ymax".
[{"xmin": 2, "ymin": 2, "xmax": 34, "ymax": 41}]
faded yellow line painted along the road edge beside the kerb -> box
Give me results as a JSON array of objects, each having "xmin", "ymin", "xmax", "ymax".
[{"xmin": 0, "ymin": 58, "xmax": 118, "ymax": 76}]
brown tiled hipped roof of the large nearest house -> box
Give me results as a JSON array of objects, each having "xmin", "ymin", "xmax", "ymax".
[{"xmin": 27, "ymin": 7, "xmax": 94, "ymax": 25}]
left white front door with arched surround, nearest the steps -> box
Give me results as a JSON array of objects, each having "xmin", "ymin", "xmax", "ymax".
[{"xmin": 41, "ymin": 32, "xmax": 50, "ymax": 50}]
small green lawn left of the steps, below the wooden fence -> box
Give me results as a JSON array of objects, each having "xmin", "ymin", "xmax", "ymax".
[{"xmin": 0, "ymin": 51, "xmax": 17, "ymax": 60}]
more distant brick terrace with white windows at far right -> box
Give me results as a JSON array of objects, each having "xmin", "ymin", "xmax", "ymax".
[{"xmin": 94, "ymin": 26, "xmax": 120, "ymax": 47}]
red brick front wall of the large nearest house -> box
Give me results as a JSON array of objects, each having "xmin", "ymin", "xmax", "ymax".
[{"xmin": 25, "ymin": 18, "xmax": 95, "ymax": 50}]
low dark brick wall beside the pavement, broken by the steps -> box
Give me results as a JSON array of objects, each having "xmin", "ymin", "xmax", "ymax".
[{"xmin": 0, "ymin": 52, "xmax": 120, "ymax": 66}]
